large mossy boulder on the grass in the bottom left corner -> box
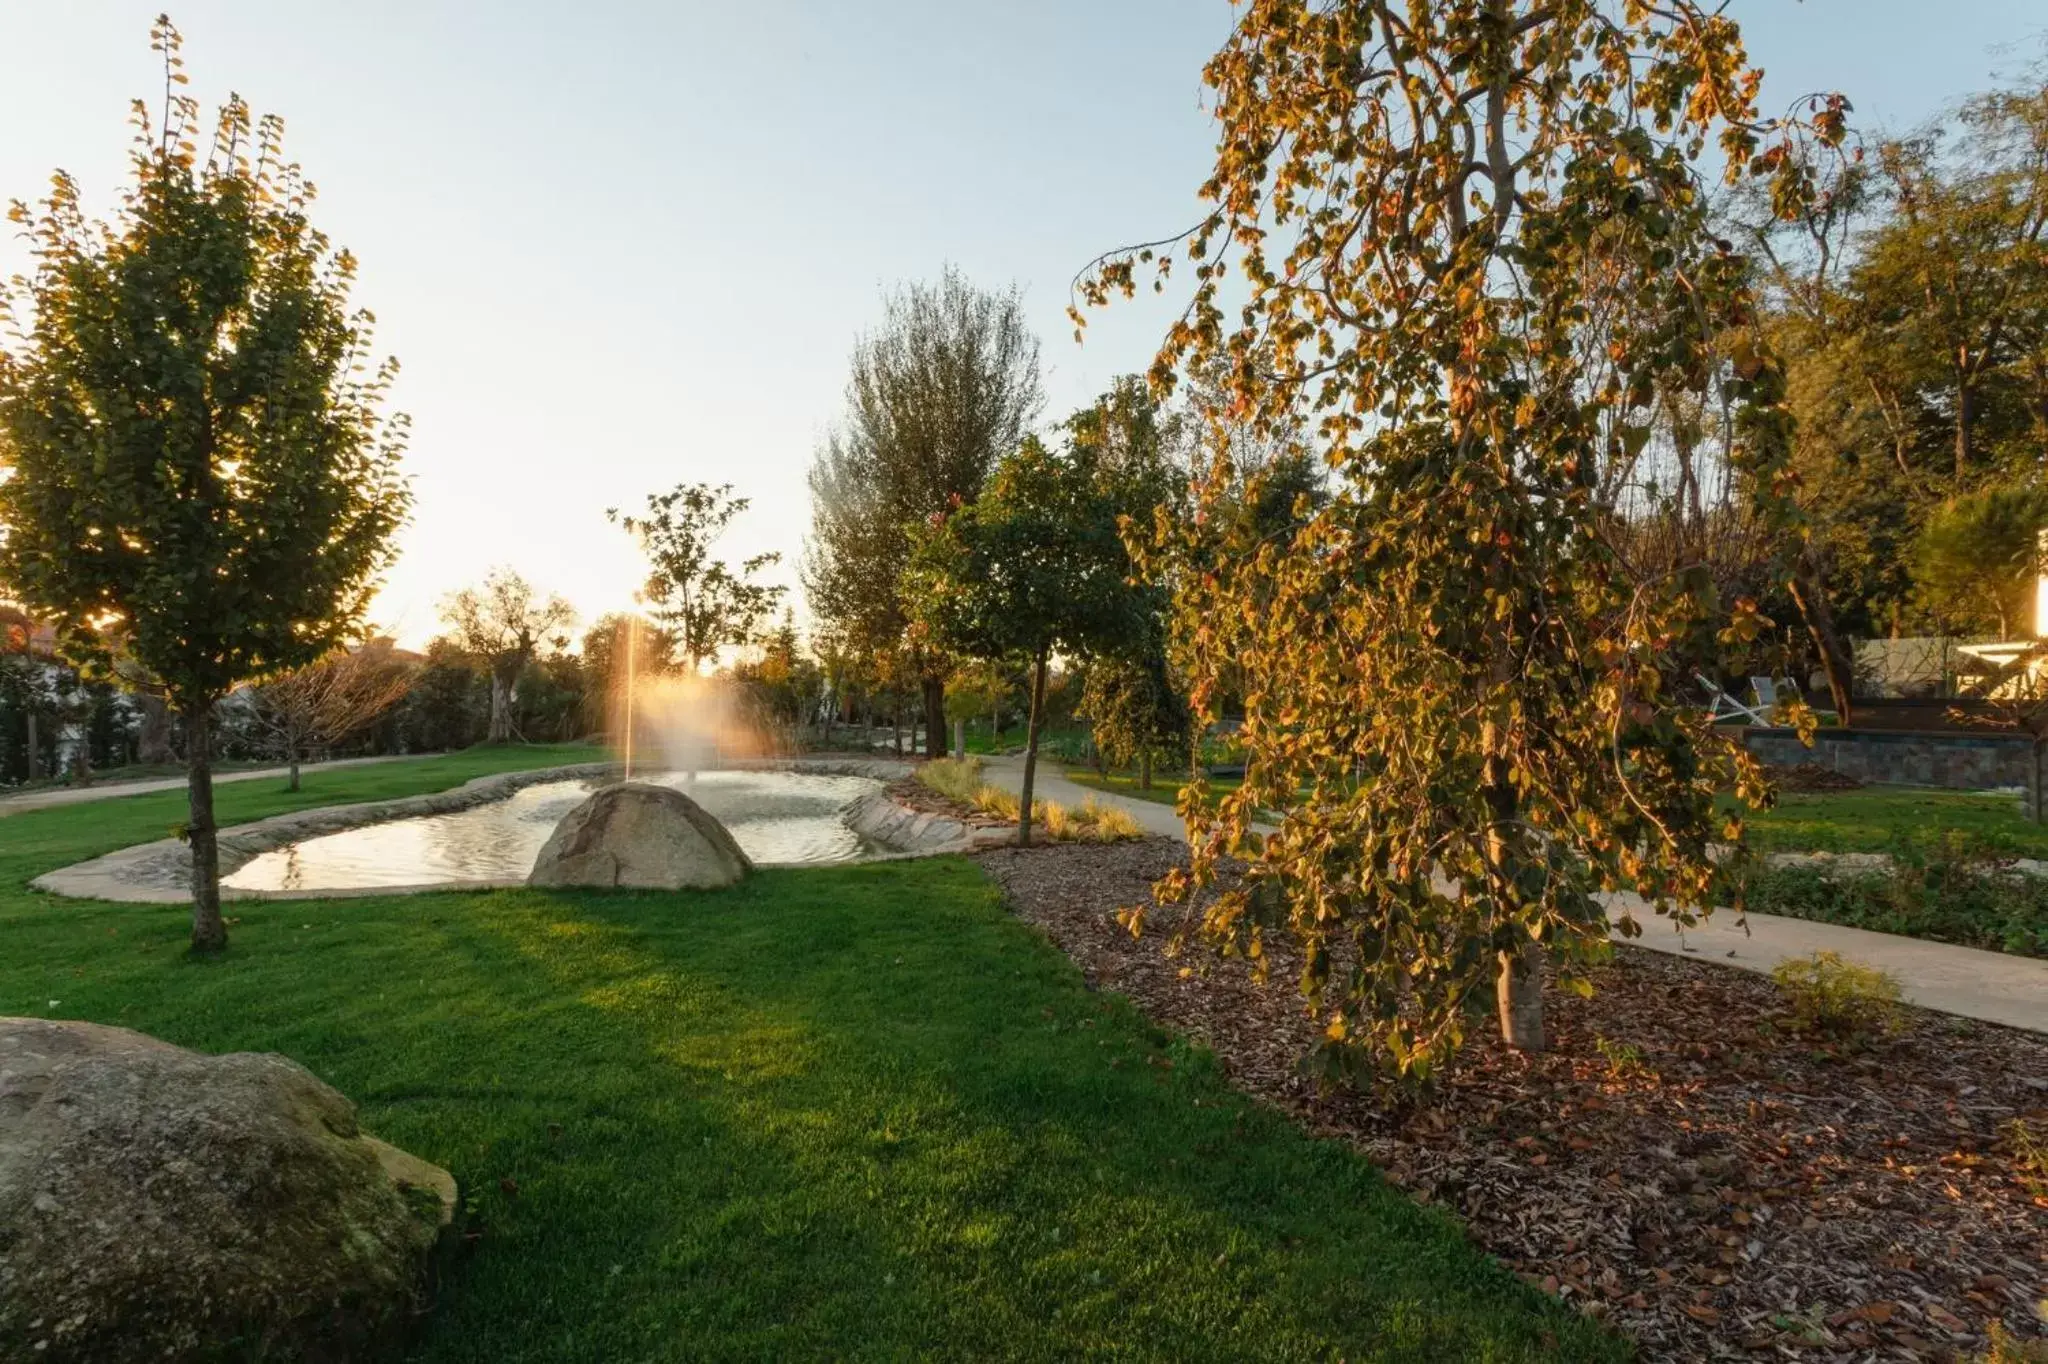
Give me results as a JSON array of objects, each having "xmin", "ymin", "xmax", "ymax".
[{"xmin": 0, "ymin": 1018, "xmax": 455, "ymax": 1364}]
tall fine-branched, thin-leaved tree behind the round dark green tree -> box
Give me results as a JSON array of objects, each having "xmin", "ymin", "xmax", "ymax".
[{"xmin": 803, "ymin": 266, "xmax": 1040, "ymax": 756}]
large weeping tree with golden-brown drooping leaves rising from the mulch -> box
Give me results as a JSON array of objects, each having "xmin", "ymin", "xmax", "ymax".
[{"xmin": 1075, "ymin": 0, "xmax": 1841, "ymax": 1071}]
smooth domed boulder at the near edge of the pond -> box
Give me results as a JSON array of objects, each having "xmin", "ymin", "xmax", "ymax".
[{"xmin": 526, "ymin": 782, "xmax": 754, "ymax": 891}]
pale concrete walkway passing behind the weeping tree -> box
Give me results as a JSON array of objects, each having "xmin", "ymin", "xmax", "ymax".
[{"xmin": 983, "ymin": 758, "xmax": 2048, "ymax": 1032}]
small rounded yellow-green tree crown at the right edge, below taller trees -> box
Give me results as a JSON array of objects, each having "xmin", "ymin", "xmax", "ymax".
[{"xmin": 1913, "ymin": 485, "xmax": 2048, "ymax": 639}]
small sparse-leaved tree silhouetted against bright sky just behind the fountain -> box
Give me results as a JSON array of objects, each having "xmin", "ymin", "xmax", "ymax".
[{"xmin": 604, "ymin": 483, "xmax": 786, "ymax": 672}]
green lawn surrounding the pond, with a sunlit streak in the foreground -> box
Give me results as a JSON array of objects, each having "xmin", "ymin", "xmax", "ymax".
[{"xmin": 0, "ymin": 750, "xmax": 1628, "ymax": 1364}]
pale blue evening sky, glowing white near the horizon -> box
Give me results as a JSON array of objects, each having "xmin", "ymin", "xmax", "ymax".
[{"xmin": 0, "ymin": 0, "xmax": 2048, "ymax": 645}]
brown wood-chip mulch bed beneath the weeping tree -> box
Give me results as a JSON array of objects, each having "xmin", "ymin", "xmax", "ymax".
[{"xmin": 979, "ymin": 840, "xmax": 2048, "ymax": 1360}]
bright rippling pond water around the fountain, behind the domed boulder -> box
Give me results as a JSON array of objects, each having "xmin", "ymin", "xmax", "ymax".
[{"xmin": 221, "ymin": 772, "xmax": 881, "ymax": 891}]
